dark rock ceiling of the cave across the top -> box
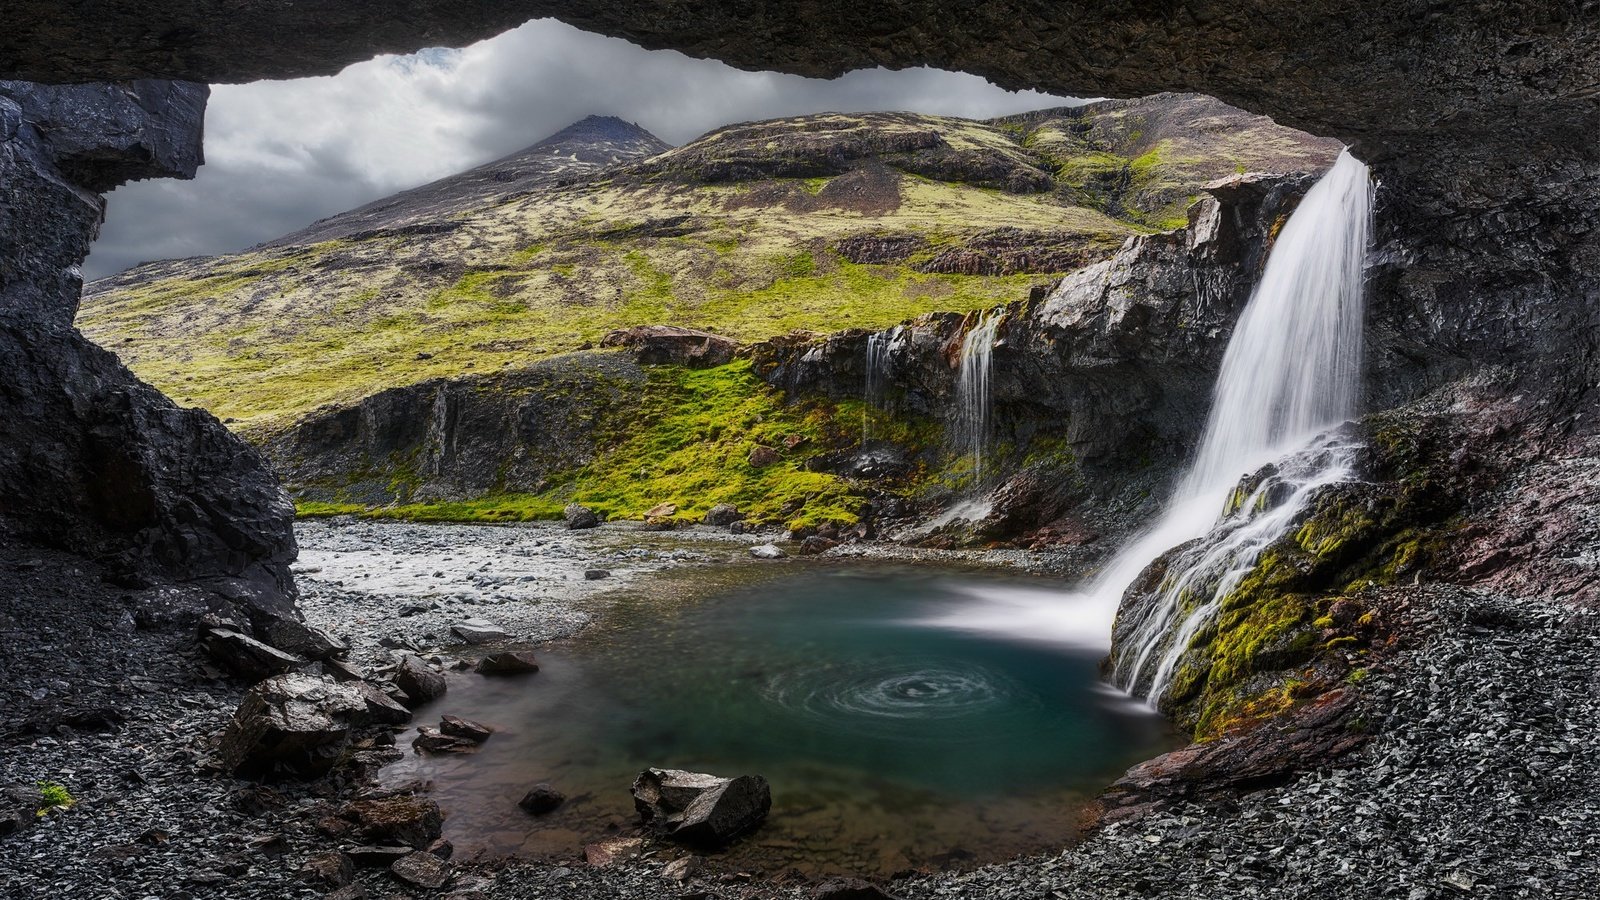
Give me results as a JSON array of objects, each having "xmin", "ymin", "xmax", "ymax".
[{"xmin": 0, "ymin": 0, "xmax": 1600, "ymax": 169}]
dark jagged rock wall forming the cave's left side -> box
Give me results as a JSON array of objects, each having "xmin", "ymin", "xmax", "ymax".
[{"xmin": 0, "ymin": 82, "xmax": 294, "ymax": 615}]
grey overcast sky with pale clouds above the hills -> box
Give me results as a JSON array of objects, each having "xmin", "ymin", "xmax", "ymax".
[{"xmin": 83, "ymin": 19, "xmax": 1077, "ymax": 279}]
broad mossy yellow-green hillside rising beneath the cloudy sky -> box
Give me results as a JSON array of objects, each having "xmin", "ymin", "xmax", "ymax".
[{"xmin": 78, "ymin": 94, "xmax": 1338, "ymax": 431}]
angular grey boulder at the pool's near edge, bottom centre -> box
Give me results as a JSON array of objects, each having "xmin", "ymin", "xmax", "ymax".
[{"xmin": 634, "ymin": 769, "xmax": 773, "ymax": 849}]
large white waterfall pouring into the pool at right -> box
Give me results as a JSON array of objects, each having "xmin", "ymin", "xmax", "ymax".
[{"xmin": 933, "ymin": 152, "xmax": 1371, "ymax": 701}]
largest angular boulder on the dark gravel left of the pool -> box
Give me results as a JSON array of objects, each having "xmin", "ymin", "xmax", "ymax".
[{"xmin": 218, "ymin": 673, "xmax": 366, "ymax": 778}]
